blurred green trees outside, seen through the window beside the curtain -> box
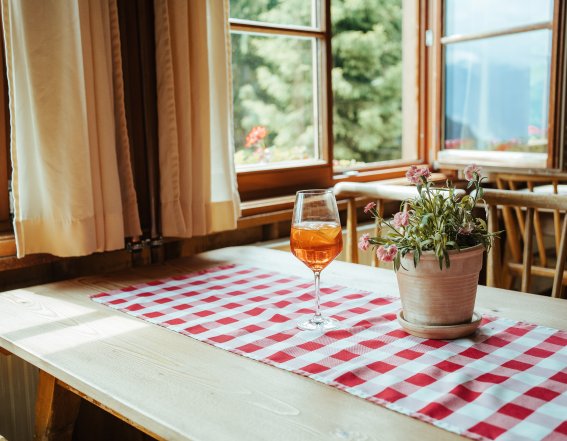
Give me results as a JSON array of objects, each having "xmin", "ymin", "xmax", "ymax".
[{"xmin": 231, "ymin": 0, "xmax": 402, "ymax": 165}]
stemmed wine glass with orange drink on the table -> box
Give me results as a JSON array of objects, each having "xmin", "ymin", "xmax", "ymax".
[{"xmin": 290, "ymin": 190, "xmax": 343, "ymax": 331}]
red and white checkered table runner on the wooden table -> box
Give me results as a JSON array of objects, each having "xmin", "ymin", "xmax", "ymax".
[{"xmin": 93, "ymin": 265, "xmax": 567, "ymax": 441}]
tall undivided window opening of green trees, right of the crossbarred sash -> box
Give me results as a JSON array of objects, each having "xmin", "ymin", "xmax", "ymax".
[{"xmin": 331, "ymin": 0, "xmax": 410, "ymax": 169}]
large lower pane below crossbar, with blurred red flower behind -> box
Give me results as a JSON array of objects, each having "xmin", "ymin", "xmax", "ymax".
[{"xmin": 232, "ymin": 33, "xmax": 319, "ymax": 165}]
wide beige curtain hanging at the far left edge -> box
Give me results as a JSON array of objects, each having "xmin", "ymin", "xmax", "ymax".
[{"xmin": 2, "ymin": 0, "xmax": 141, "ymax": 257}]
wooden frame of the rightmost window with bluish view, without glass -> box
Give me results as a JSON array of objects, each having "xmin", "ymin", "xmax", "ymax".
[{"xmin": 427, "ymin": 0, "xmax": 567, "ymax": 173}]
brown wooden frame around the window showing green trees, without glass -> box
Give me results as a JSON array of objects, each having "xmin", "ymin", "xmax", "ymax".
[{"xmin": 229, "ymin": 0, "xmax": 430, "ymax": 201}]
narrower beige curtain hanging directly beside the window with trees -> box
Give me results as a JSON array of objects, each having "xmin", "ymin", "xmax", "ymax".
[{"xmin": 154, "ymin": 0, "xmax": 240, "ymax": 237}]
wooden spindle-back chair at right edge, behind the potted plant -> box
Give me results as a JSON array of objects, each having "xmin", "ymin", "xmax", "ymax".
[{"xmin": 484, "ymin": 189, "xmax": 567, "ymax": 297}]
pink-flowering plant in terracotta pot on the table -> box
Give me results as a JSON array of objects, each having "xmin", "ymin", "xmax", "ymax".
[{"xmin": 358, "ymin": 164, "xmax": 494, "ymax": 338}]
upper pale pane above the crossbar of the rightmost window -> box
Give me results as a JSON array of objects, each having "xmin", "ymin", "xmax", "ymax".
[{"xmin": 445, "ymin": 0, "xmax": 553, "ymax": 35}]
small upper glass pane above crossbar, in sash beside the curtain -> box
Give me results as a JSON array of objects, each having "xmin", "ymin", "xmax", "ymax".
[{"xmin": 230, "ymin": 0, "xmax": 317, "ymax": 27}]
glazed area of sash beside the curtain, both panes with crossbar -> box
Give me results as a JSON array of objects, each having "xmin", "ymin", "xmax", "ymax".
[{"xmin": 231, "ymin": 0, "xmax": 324, "ymax": 170}]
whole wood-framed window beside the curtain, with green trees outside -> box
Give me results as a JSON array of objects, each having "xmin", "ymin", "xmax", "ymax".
[{"xmin": 230, "ymin": 0, "xmax": 423, "ymax": 199}]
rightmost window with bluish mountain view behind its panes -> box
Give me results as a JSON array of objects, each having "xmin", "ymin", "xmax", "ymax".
[{"xmin": 438, "ymin": 0, "xmax": 559, "ymax": 168}]
